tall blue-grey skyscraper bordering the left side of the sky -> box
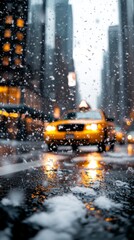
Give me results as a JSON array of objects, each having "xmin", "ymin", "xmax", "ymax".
[{"xmin": 44, "ymin": 0, "xmax": 75, "ymax": 116}]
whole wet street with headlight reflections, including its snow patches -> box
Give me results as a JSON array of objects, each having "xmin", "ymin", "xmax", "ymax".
[{"xmin": 0, "ymin": 141, "xmax": 134, "ymax": 240}]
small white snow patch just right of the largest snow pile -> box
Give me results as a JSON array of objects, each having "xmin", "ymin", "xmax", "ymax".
[{"xmin": 94, "ymin": 196, "xmax": 122, "ymax": 210}]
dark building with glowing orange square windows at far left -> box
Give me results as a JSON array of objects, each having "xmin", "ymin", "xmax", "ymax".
[{"xmin": 0, "ymin": 0, "xmax": 45, "ymax": 110}]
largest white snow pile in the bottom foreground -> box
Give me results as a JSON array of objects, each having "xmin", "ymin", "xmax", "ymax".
[{"xmin": 26, "ymin": 194, "xmax": 86, "ymax": 240}]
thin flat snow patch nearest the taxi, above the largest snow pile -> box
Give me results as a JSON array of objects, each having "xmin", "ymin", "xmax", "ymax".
[{"xmin": 71, "ymin": 186, "xmax": 96, "ymax": 196}]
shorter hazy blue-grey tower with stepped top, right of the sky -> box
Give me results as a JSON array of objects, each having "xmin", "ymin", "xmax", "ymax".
[{"xmin": 101, "ymin": 26, "xmax": 121, "ymax": 123}]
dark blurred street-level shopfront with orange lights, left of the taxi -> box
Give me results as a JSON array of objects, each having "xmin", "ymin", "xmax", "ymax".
[{"xmin": 0, "ymin": 104, "xmax": 45, "ymax": 141}]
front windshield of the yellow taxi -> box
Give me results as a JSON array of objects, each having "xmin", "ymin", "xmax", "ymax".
[{"xmin": 63, "ymin": 111, "xmax": 102, "ymax": 120}]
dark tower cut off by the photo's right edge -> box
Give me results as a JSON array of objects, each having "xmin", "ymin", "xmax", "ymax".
[{"xmin": 118, "ymin": 0, "xmax": 134, "ymax": 122}]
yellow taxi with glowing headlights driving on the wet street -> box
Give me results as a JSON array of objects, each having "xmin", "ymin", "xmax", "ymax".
[{"xmin": 44, "ymin": 110, "xmax": 115, "ymax": 152}]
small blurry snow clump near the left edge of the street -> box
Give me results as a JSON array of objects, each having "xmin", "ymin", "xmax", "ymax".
[{"xmin": 1, "ymin": 190, "xmax": 24, "ymax": 207}]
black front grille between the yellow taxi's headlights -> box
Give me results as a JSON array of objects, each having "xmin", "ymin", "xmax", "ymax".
[{"xmin": 58, "ymin": 124, "xmax": 84, "ymax": 132}]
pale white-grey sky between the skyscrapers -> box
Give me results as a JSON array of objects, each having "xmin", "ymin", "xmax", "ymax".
[{"xmin": 70, "ymin": 0, "xmax": 118, "ymax": 107}]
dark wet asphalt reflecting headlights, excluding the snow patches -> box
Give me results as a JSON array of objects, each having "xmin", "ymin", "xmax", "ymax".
[{"xmin": 0, "ymin": 143, "xmax": 134, "ymax": 240}]
